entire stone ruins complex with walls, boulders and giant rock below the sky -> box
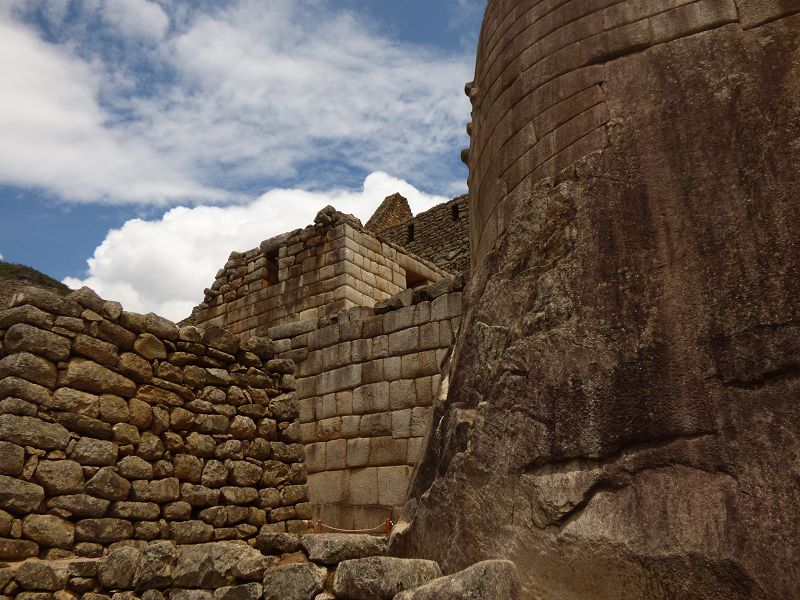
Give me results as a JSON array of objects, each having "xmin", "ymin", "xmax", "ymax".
[{"xmin": 0, "ymin": 0, "xmax": 800, "ymax": 600}]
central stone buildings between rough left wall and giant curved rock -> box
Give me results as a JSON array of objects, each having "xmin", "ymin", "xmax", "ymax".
[{"xmin": 190, "ymin": 194, "xmax": 469, "ymax": 529}]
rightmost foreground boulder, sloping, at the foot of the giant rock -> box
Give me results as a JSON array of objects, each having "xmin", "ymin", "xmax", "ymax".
[{"xmin": 394, "ymin": 560, "xmax": 522, "ymax": 600}]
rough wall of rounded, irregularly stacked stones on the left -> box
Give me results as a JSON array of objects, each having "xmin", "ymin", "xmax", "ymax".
[{"xmin": 0, "ymin": 288, "xmax": 311, "ymax": 561}]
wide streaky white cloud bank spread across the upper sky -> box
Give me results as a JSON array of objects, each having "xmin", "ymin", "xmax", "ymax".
[{"xmin": 0, "ymin": 0, "xmax": 472, "ymax": 204}]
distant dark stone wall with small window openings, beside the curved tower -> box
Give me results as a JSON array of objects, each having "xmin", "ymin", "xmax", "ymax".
[{"xmin": 381, "ymin": 196, "xmax": 470, "ymax": 275}]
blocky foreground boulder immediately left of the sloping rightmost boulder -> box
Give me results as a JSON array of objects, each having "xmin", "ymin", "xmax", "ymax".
[{"xmin": 333, "ymin": 556, "xmax": 442, "ymax": 600}]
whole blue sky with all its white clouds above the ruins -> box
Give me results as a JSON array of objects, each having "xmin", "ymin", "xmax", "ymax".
[{"xmin": 0, "ymin": 0, "xmax": 484, "ymax": 319}]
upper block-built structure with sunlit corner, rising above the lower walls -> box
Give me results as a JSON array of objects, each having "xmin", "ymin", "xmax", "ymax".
[{"xmin": 190, "ymin": 207, "xmax": 446, "ymax": 338}]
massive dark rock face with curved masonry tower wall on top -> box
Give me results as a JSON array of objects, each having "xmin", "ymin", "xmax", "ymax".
[{"xmin": 392, "ymin": 0, "xmax": 800, "ymax": 600}]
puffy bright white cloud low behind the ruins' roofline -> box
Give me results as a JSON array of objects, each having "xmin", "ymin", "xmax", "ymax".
[{"xmin": 64, "ymin": 172, "xmax": 447, "ymax": 320}]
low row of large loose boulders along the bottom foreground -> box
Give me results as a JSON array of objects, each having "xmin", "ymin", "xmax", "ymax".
[{"xmin": 0, "ymin": 533, "xmax": 520, "ymax": 600}]
